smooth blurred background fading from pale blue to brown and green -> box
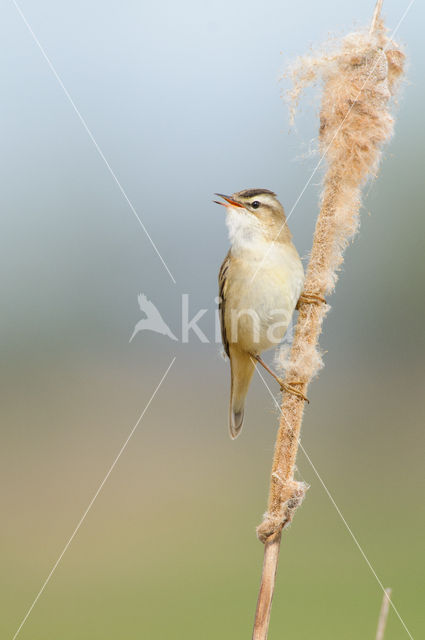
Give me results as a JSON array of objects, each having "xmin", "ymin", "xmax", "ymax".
[{"xmin": 0, "ymin": 0, "xmax": 425, "ymax": 640}]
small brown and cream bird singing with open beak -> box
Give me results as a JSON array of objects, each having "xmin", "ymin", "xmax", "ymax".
[{"xmin": 216, "ymin": 189, "xmax": 304, "ymax": 438}]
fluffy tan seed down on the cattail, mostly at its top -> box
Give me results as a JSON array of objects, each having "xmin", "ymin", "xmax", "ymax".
[{"xmin": 276, "ymin": 22, "xmax": 405, "ymax": 379}]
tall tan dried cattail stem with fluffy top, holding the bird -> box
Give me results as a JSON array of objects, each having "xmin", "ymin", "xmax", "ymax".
[{"xmin": 253, "ymin": 2, "xmax": 404, "ymax": 640}]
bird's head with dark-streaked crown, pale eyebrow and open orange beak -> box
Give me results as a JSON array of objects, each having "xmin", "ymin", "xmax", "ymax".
[{"xmin": 214, "ymin": 189, "xmax": 291, "ymax": 242}]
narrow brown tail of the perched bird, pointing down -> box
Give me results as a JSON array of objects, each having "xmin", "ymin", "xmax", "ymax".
[{"xmin": 229, "ymin": 347, "xmax": 255, "ymax": 440}]
